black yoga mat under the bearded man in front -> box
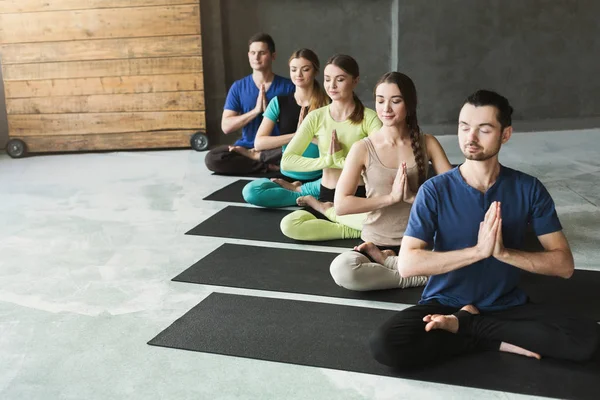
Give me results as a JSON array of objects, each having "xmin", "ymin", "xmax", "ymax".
[{"xmin": 148, "ymin": 293, "xmax": 600, "ymax": 399}]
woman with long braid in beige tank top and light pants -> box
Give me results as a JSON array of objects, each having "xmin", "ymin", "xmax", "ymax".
[{"xmin": 330, "ymin": 72, "xmax": 452, "ymax": 291}]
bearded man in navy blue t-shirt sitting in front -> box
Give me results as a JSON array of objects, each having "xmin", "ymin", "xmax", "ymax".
[{"xmin": 371, "ymin": 90, "xmax": 598, "ymax": 368}]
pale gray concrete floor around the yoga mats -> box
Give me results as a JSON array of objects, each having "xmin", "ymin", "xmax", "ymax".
[{"xmin": 0, "ymin": 129, "xmax": 600, "ymax": 400}]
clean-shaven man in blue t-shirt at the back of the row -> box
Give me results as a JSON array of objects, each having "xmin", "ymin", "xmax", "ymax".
[{"xmin": 205, "ymin": 33, "xmax": 295, "ymax": 175}]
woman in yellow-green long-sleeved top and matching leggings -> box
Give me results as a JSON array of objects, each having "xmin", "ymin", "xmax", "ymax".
[{"xmin": 281, "ymin": 54, "xmax": 381, "ymax": 241}]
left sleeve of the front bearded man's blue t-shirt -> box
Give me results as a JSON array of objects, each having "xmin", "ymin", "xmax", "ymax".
[{"xmin": 404, "ymin": 181, "xmax": 438, "ymax": 244}]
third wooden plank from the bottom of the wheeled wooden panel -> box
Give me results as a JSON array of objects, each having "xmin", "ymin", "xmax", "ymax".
[{"xmin": 6, "ymin": 91, "xmax": 204, "ymax": 115}]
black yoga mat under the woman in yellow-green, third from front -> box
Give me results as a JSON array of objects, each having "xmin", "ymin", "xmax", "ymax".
[{"xmin": 186, "ymin": 206, "xmax": 361, "ymax": 248}]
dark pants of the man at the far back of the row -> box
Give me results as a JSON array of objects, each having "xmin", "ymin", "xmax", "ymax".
[{"xmin": 204, "ymin": 145, "xmax": 282, "ymax": 175}]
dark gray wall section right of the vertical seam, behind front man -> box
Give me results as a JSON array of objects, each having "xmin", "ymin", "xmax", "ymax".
[{"xmin": 397, "ymin": 0, "xmax": 600, "ymax": 131}]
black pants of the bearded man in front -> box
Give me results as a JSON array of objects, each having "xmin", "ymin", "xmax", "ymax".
[{"xmin": 370, "ymin": 303, "xmax": 598, "ymax": 369}]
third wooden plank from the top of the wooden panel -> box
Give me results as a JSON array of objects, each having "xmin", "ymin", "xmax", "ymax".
[{"xmin": 0, "ymin": 35, "xmax": 202, "ymax": 65}]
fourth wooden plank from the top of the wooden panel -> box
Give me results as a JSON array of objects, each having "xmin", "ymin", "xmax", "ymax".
[{"xmin": 2, "ymin": 56, "xmax": 202, "ymax": 82}]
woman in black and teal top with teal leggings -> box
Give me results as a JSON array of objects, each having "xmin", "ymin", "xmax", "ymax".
[{"xmin": 242, "ymin": 49, "xmax": 329, "ymax": 207}]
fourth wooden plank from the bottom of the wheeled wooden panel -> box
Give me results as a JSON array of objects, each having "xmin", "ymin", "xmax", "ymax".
[{"xmin": 4, "ymin": 73, "xmax": 204, "ymax": 99}]
